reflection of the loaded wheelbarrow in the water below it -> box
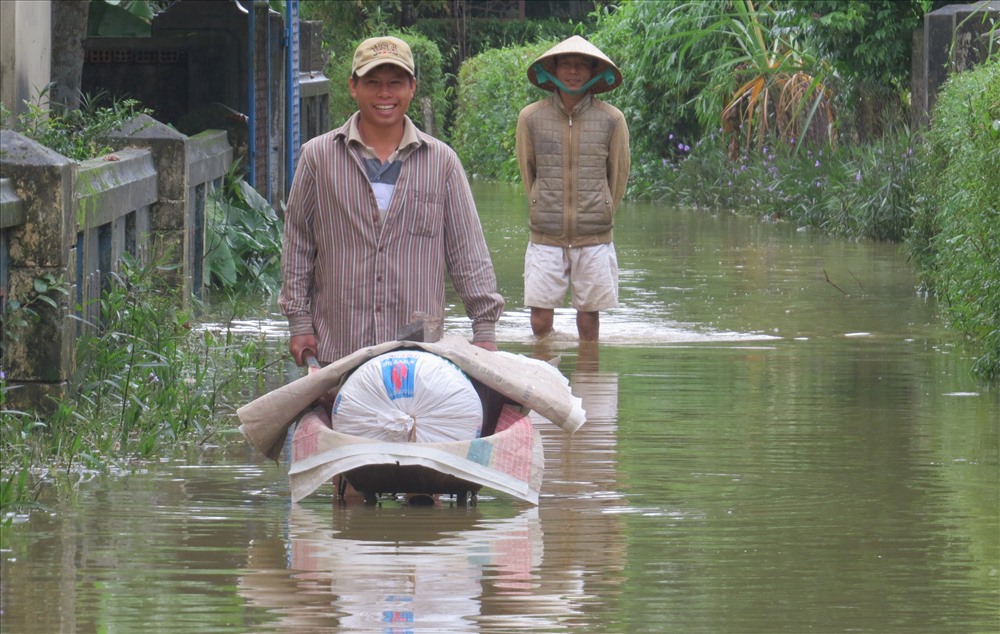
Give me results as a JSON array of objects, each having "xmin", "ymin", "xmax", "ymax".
[{"xmin": 239, "ymin": 505, "xmax": 584, "ymax": 632}]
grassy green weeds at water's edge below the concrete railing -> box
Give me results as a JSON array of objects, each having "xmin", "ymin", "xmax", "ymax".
[{"xmin": 0, "ymin": 249, "xmax": 267, "ymax": 508}]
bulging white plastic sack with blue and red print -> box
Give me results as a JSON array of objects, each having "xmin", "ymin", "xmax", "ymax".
[{"xmin": 330, "ymin": 350, "xmax": 483, "ymax": 442}]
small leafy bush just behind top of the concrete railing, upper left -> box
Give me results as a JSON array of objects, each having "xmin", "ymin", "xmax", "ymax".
[{"xmin": 4, "ymin": 84, "xmax": 152, "ymax": 161}]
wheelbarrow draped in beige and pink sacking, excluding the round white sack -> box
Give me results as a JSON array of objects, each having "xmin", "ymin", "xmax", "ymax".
[{"xmin": 237, "ymin": 337, "xmax": 585, "ymax": 504}]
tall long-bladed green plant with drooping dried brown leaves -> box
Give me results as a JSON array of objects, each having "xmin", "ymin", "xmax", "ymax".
[{"xmin": 595, "ymin": 0, "xmax": 833, "ymax": 157}]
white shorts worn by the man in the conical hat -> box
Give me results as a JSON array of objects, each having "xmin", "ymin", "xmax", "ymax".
[{"xmin": 524, "ymin": 242, "xmax": 618, "ymax": 313}]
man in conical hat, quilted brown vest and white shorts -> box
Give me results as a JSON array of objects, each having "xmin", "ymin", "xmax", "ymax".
[{"xmin": 516, "ymin": 35, "xmax": 631, "ymax": 341}]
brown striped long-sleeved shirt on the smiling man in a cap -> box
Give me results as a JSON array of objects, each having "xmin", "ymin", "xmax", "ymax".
[{"xmin": 278, "ymin": 114, "xmax": 504, "ymax": 362}]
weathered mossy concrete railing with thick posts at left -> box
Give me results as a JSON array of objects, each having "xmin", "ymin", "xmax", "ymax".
[{"xmin": 0, "ymin": 115, "xmax": 233, "ymax": 408}]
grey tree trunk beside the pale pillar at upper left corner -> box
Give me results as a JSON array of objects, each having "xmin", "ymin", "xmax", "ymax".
[{"xmin": 49, "ymin": 0, "xmax": 90, "ymax": 110}]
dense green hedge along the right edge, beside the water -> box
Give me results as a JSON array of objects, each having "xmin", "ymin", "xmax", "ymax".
[{"xmin": 909, "ymin": 55, "xmax": 1000, "ymax": 379}]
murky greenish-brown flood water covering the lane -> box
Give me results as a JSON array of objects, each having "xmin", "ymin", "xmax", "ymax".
[{"xmin": 0, "ymin": 184, "xmax": 1000, "ymax": 633}]
